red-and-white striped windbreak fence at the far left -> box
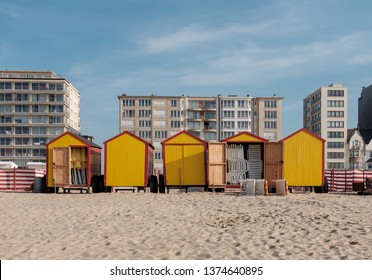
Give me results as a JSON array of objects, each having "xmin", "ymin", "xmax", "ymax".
[{"xmin": 0, "ymin": 168, "xmax": 45, "ymax": 190}]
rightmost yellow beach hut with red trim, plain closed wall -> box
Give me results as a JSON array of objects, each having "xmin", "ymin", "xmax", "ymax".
[{"xmin": 280, "ymin": 128, "xmax": 325, "ymax": 191}]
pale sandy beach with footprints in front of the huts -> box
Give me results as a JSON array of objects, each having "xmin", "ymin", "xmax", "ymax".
[{"xmin": 0, "ymin": 192, "xmax": 372, "ymax": 260}]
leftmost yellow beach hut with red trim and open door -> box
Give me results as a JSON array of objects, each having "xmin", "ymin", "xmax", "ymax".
[{"xmin": 46, "ymin": 132, "xmax": 101, "ymax": 192}]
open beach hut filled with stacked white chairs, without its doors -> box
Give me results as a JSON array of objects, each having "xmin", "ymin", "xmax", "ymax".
[{"xmin": 222, "ymin": 131, "xmax": 269, "ymax": 185}]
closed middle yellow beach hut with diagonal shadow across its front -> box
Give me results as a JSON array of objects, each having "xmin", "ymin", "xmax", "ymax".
[{"xmin": 162, "ymin": 131, "xmax": 207, "ymax": 191}]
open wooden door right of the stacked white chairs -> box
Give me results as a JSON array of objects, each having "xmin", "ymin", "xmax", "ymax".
[{"xmin": 264, "ymin": 142, "xmax": 285, "ymax": 184}]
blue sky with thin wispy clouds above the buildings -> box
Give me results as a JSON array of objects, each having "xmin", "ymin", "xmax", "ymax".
[{"xmin": 0, "ymin": 0, "xmax": 372, "ymax": 148}]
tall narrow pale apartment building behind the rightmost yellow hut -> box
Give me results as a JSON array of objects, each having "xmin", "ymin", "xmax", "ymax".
[{"xmin": 303, "ymin": 83, "xmax": 348, "ymax": 169}]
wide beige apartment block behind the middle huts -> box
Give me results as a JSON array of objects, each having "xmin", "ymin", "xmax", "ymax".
[{"xmin": 118, "ymin": 94, "xmax": 283, "ymax": 171}]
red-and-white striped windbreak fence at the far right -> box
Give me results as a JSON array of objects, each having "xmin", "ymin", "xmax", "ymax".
[{"xmin": 324, "ymin": 169, "xmax": 372, "ymax": 192}]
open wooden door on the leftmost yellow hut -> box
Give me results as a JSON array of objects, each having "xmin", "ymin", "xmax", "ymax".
[{"xmin": 53, "ymin": 147, "xmax": 71, "ymax": 187}]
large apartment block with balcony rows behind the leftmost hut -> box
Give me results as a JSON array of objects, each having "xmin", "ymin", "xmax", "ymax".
[{"xmin": 0, "ymin": 70, "xmax": 81, "ymax": 167}]
